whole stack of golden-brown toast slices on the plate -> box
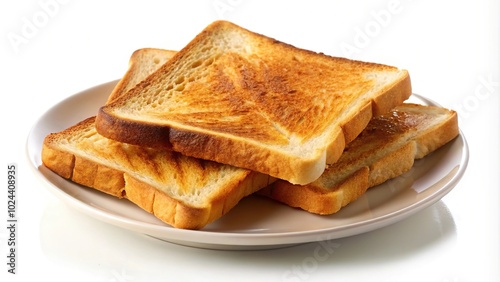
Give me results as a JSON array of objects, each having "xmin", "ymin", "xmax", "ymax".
[{"xmin": 42, "ymin": 21, "xmax": 458, "ymax": 229}]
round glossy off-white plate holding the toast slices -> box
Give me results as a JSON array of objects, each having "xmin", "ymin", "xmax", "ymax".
[{"xmin": 27, "ymin": 81, "xmax": 468, "ymax": 250}]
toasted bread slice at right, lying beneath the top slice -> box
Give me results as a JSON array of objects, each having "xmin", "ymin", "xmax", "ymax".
[{"xmin": 258, "ymin": 104, "xmax": 459, "ymax": 214}]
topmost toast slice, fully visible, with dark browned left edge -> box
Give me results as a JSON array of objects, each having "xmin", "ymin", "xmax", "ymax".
[{"xmin": 96, "ymin": 21, "xmax": 411, "ymax": 184}]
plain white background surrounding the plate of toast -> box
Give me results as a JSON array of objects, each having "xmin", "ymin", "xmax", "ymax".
[{"xmin": 0, "ymin": 0, "xmax": 500, "ymax": 282}]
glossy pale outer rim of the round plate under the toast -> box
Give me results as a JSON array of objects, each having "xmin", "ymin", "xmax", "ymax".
[{"xmin": 25, "ymin": 79, "xmax": 469, "ymax": 250}]
